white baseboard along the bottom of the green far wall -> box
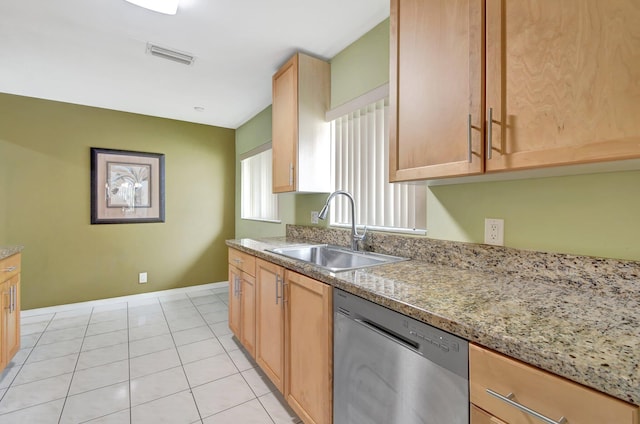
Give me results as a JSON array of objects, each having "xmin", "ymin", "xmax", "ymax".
[{"xmin": 20, "ymin": 281, "xmax": 229, "ymax": 317}]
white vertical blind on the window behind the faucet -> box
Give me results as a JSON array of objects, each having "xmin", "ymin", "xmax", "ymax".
[{"xmin": 330, "ymin": 99, "xmax": 427, "ymax": 233}]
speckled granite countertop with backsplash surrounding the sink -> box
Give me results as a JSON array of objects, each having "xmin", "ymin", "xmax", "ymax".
[{"xmin": 227, "ymin": 227, "xmax": 640, "ymax": 405}]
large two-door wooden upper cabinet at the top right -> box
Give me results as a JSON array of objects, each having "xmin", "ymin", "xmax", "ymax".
[{"xmin": 390, "ymin": 0, "xmax": 640, "ymax": 181}]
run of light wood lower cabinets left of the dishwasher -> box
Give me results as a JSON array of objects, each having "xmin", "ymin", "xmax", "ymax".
[{"xmin": 229, "ymin": 252, "xmax": 333, "ymax": 424}]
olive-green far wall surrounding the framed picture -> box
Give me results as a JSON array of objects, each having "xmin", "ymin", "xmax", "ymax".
[{"xmin": 0, "ymin": 94, "xmax": 235, "ymax": 309}]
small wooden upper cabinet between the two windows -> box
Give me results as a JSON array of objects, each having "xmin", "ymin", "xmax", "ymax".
[{"xmin": 272, "ymin": 53, "xmax": 331, "ymax": 193}]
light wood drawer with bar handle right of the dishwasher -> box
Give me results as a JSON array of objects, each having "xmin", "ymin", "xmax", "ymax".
[{"xmin": 469, "ymin": 344, "xmax": 638, "ymax": 424}]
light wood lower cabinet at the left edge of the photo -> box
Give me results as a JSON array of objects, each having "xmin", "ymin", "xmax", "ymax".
[{"xmin": 0, "ymin": 253, "xmax": 21, "ymax": 370}]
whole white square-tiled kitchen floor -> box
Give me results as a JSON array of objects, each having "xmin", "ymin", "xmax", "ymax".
[{"xmin": 0, "ymin": 285, "xmax": 300, "ymax": 424}]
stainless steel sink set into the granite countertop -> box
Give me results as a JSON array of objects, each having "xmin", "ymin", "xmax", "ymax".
[{"xmin": 268, "ymin": 244, "xmax": 407, "ymax": 272}]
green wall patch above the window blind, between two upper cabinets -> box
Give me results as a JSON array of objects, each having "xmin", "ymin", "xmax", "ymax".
[{"xmin": 331, "ymin": 19, "xmax": 389, "ymax": 108}]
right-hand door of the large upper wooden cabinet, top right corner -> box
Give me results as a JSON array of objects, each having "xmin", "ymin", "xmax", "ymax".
[{"xmin": 486, "ymin": 0, "xmax": 640, "ymax": 171}]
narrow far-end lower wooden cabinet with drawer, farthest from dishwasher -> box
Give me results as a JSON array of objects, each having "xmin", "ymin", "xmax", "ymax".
[{"xmin": 229, "ymin": 249, "xmax": 256, "ymax": 357}]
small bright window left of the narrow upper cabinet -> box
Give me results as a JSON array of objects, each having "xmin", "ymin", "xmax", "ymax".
[{"xmin": 240, "ymin": 143, "xmax": 280, "ymax": 222}]
